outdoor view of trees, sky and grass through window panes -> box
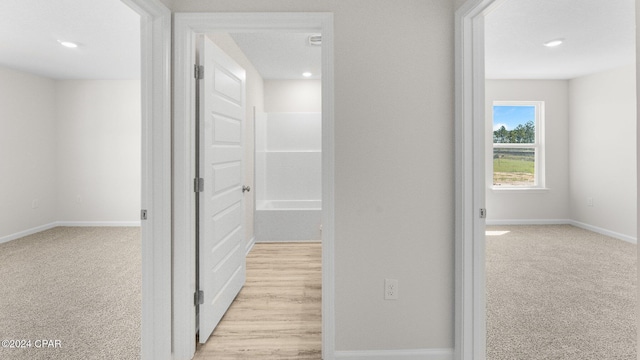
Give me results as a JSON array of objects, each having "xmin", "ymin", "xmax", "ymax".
[{"xmin": 493, "ymin": 105, "xmax": 537, "ymax": 187}]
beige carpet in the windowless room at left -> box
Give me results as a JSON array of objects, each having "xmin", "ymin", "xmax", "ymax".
[{"xmin": 0, "ymin": 227, "xmax": 142, "ymax": 360}]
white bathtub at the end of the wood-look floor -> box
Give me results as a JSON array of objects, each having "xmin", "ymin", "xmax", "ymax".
[{"xmin": 254, "ymin": 200, "xmax": 322, "ymax": 242}]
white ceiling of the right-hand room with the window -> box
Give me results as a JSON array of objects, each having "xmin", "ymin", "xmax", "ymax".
[{"xmin": 485, "ymin": 0, "xmax": 635, "ymax": 79}]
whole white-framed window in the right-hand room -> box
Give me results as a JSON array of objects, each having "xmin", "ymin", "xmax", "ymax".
[{"xmin": 493, "ymin": 101, "xmax": 544, "ymax": 189}]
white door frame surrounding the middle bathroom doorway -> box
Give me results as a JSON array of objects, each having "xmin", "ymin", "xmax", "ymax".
[{"xmin": 173, "ymin": 13, "xmax": 335, "ymax": 360}]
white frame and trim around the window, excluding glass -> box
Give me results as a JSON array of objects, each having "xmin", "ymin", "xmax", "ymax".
[{"xmin": 488, "ymin": 101, "xmax": 547, "ymax": 191}]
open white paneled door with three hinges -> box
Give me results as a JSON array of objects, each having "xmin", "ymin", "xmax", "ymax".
[{"xmin": 198, "ymin": 36, "xmax": 246, "ymax": 343}]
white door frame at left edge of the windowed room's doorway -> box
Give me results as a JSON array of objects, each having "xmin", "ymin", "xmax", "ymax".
[{"xmin": 454, "ymin": 0, "xmax": 506, "ymax": 360}]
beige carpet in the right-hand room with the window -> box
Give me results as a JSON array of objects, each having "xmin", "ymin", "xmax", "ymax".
[{"xmin": 486, "ymin": 225, "xmax": 637, "ymax": 360}]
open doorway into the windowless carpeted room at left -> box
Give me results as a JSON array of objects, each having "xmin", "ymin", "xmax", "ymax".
[{"xmin": 0, "ymin": 1, "xmax": 146, "ymax": 358}]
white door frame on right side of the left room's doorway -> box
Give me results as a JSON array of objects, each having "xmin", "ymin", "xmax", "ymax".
[{"xmin": 121, "ymin": 0, "xmax": 171, "ymax": 360}]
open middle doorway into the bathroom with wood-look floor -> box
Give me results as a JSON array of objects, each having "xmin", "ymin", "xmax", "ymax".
[{"xmin": 190, "ymin": 32, "xmax": 322, "ymax": 359}]
